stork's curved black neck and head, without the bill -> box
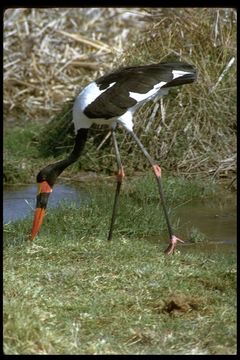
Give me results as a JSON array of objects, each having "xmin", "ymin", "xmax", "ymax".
[{"xmin": 37, "ymin": 129, "xmax": 88, "ymax": 187}]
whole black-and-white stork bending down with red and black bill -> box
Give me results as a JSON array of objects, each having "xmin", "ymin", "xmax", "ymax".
[{"xmin": 30, "ymin": 62, "xmax": 197, "ymax": 254}]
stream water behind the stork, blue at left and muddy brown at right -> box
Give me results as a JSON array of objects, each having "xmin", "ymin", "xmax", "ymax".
[{"xmin": 3, "ymin": 184, "xmax": 236, "ymax": 251}]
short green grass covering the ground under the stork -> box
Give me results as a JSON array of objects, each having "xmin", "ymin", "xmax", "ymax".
[{"xmin": 4, "ymin": 176, "xmax": 236, "ymax": 354}]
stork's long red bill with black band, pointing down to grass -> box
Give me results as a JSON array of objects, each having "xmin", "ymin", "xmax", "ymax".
[{"xmin": 30, "ymin": 181, "xmax": 52, "ymax": 240}]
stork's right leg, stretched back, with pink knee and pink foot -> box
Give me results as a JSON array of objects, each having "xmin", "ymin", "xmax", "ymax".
[{"xmin": 130, "ymin": 131, "xmax": 183, "ymax": 254}]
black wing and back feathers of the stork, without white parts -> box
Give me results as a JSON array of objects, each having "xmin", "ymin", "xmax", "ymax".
[{"xmin": 84, "ymin": 62, "xmax": 196, "ymax": 119}]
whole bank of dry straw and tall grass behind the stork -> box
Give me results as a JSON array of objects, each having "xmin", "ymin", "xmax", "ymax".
[{"xmin": 4, "ymin": 8, "xmax": 236, "ymax": 179}]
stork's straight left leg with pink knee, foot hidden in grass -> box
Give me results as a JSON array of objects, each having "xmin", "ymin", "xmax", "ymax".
[{"xmin": 108, "ymin": 129, "xmax": 125, "ymax": 240}]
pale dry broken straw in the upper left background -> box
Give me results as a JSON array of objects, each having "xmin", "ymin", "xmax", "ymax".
[{"xmin": 4, "ymin": 8, "xmax": 146, "ymax": 122}]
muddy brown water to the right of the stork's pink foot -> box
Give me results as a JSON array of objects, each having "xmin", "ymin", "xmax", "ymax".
[{"xmin": 174, "ymin": 192, "xmax": 237, "ymax": 251}]
